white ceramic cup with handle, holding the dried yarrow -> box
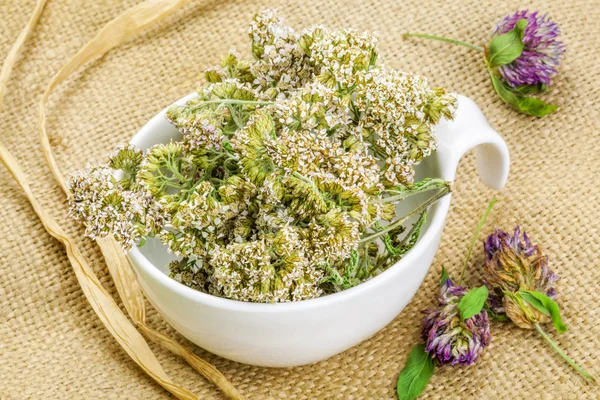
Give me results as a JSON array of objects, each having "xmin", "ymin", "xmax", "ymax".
[{"xmin": 129, "ymin": 95, "xmax": 509, "ymax": 367}]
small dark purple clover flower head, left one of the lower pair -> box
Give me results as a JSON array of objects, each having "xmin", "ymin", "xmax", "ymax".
[{"xmin": 422, "ymin": 279, "xmax": 492, "ymax": 365}]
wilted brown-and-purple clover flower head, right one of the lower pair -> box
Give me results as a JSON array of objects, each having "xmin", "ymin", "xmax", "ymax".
[{"xmin": 483, "ymin": 226, "xmax": 559, "ymax": 328}]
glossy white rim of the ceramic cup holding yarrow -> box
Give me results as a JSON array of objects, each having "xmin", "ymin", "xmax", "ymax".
[{"xmin": 127, "ymin": 93, "xmax": 452, "ymax": 312}]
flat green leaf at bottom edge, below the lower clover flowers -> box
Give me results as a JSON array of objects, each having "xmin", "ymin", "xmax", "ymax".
[{"xmin": 396, "ymin": 344, "xmax": 433, "ymax": 400}]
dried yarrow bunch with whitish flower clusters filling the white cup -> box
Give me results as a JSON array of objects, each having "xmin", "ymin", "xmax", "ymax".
[{"xmin": 69, "ymin": 11, "xmax": 456, "ymax": 303}]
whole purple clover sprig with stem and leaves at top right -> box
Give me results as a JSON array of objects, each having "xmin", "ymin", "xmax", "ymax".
[{"xmin": 404, "ymin": 10, "xmax": 565, "ymax": 117}]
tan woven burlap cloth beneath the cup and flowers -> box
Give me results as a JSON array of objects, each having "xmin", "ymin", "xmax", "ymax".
[{"xmin": 0, "ymin": 0, "xmax": 600, "ymax": 399}]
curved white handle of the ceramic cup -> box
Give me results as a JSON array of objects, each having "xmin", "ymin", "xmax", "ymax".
[{"xmin": 436, "ymin": 95, "xmax": 510, "ymax": 190}]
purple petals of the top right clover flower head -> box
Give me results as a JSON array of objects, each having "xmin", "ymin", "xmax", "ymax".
[{"xmin": 493, "ymin": 10, "xmax": 565, "ymax": 88}]
